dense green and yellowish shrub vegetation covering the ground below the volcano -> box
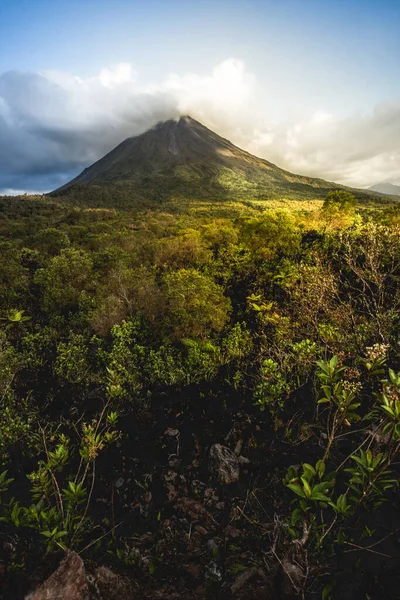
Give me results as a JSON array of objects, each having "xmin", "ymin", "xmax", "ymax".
[{"xmin": 0, "ymin": 191, "xmax": 400, "ymax": 600}]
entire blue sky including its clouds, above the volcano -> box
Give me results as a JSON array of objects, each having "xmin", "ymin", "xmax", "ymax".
[{"xmin": 0, "ymin": 0, "xmax": 400, "ymax": 194}]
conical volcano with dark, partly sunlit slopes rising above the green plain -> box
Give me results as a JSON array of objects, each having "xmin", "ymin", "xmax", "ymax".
[{"xmin": 52, "ymin": 116, "xmax": 376, "ymax": 202}]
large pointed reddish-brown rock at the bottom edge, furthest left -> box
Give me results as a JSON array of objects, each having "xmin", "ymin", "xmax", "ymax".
[{"xmin": 25, "ymin": 552, "xmax": 88, "ymax": 600}]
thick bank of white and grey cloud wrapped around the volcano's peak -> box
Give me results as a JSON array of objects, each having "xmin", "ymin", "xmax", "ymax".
[{"xmin": 0, "ymin": 59, "xmax": 400, "ymax": 193}]
